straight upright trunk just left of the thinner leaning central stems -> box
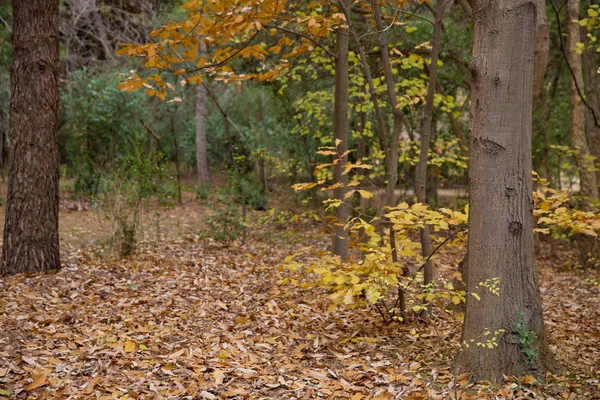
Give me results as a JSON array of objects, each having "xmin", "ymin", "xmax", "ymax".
[{"xmin": 333, "ymin": 0, "xmax": 350, "ymax": 260}]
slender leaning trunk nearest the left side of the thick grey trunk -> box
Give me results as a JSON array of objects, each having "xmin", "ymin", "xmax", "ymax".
[{"xmin": 415, "ymin": 0, "xmax": 446, "ymax": 304}]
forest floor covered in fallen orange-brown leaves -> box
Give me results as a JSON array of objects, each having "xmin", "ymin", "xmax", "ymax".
[{"xmin": 0, "ymin": 193, "xmax": 600, "ymax": 400}]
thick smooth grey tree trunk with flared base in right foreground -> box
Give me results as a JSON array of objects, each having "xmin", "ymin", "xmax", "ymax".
[{"xmin": 456, "ymin": 0, "xmax": 555, "ymax": 381}]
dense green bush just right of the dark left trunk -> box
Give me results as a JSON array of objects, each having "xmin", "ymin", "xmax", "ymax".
[{"xmin": 60, "ymin": 69, "xmax": 148, "ymax": 195}]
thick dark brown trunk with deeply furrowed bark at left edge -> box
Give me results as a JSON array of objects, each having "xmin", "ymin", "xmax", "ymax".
[{"xmin": 0, "ymin": 0, "xmax": 60, "ymax": 274}]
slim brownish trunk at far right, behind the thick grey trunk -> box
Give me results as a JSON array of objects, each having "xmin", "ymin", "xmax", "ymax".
[{"xmin": 567, "ymin": 0, "xmax": 598, "ymax": 199}]
